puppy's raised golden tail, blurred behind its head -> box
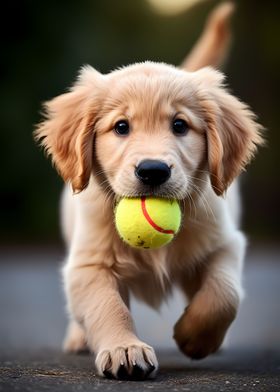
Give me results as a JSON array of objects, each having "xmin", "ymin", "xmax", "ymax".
[{"xmin": 181, "ymin": 1, "xmax": 235, "ymax": 71}]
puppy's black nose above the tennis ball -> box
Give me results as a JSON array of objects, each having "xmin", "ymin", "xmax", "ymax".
[{"xmin": 135, "ymin": 159, "xmax": 171, "ymax": 186}]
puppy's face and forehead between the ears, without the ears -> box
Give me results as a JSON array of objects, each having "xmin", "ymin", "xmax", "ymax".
[{"xmin": 95, "ymin": 64, "xmax": 206, "ymax": 199}]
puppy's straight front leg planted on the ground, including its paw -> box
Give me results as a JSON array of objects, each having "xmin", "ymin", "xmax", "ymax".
[{"xmin": 64, "ymin": 264, "xmax": 158, "ymax": 379}]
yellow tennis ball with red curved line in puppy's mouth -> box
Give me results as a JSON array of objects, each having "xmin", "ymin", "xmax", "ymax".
[{"xmin": 115, "ymin": 196, "xmax": 181, "ymax": 249}]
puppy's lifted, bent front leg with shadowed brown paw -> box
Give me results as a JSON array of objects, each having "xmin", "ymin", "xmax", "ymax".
[{"xmin": 174, "ymin": 232, "xmax": 246, "ymax": 359}]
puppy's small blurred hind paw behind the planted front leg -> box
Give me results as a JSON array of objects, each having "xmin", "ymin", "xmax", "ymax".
[{"xmin": 63, "ymin": 322, "xmax": 88, "ymax": 353}]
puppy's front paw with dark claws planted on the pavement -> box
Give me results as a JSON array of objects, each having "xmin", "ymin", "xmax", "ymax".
[{"xmin": 95, "ymin": 344, "xmax": 158, "ymax": 380}]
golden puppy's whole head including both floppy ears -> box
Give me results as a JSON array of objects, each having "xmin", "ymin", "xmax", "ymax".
[{"xmin": 36, "ymin": 63, "xmax": 262, "ymax": 199}]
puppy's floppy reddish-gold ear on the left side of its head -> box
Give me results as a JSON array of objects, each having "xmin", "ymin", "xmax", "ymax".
[{"xmin": 35, "ymin": 66, "xmax": 102, "ymax": 192}]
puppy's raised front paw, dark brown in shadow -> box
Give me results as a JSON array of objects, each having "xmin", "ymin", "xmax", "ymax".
[{"xmin": 174, "ymin": 309, "xmax": 232, "ymax": 359}]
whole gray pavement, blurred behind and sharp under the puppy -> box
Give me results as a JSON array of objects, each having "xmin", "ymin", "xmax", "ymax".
[{"xmin": 0, "ymin": 246, "xmax": 280, "ymax": 392}]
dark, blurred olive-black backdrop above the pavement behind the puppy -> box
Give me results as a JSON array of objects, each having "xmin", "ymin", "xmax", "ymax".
[{"xmin": 0, "ymin": 0, "xmax": 280, "ymax": 244}]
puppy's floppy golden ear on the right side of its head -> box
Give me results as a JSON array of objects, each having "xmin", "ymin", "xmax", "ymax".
[{"xmin": 196, "ymin": 68, "xmax": 264, "ymax": 195}]
